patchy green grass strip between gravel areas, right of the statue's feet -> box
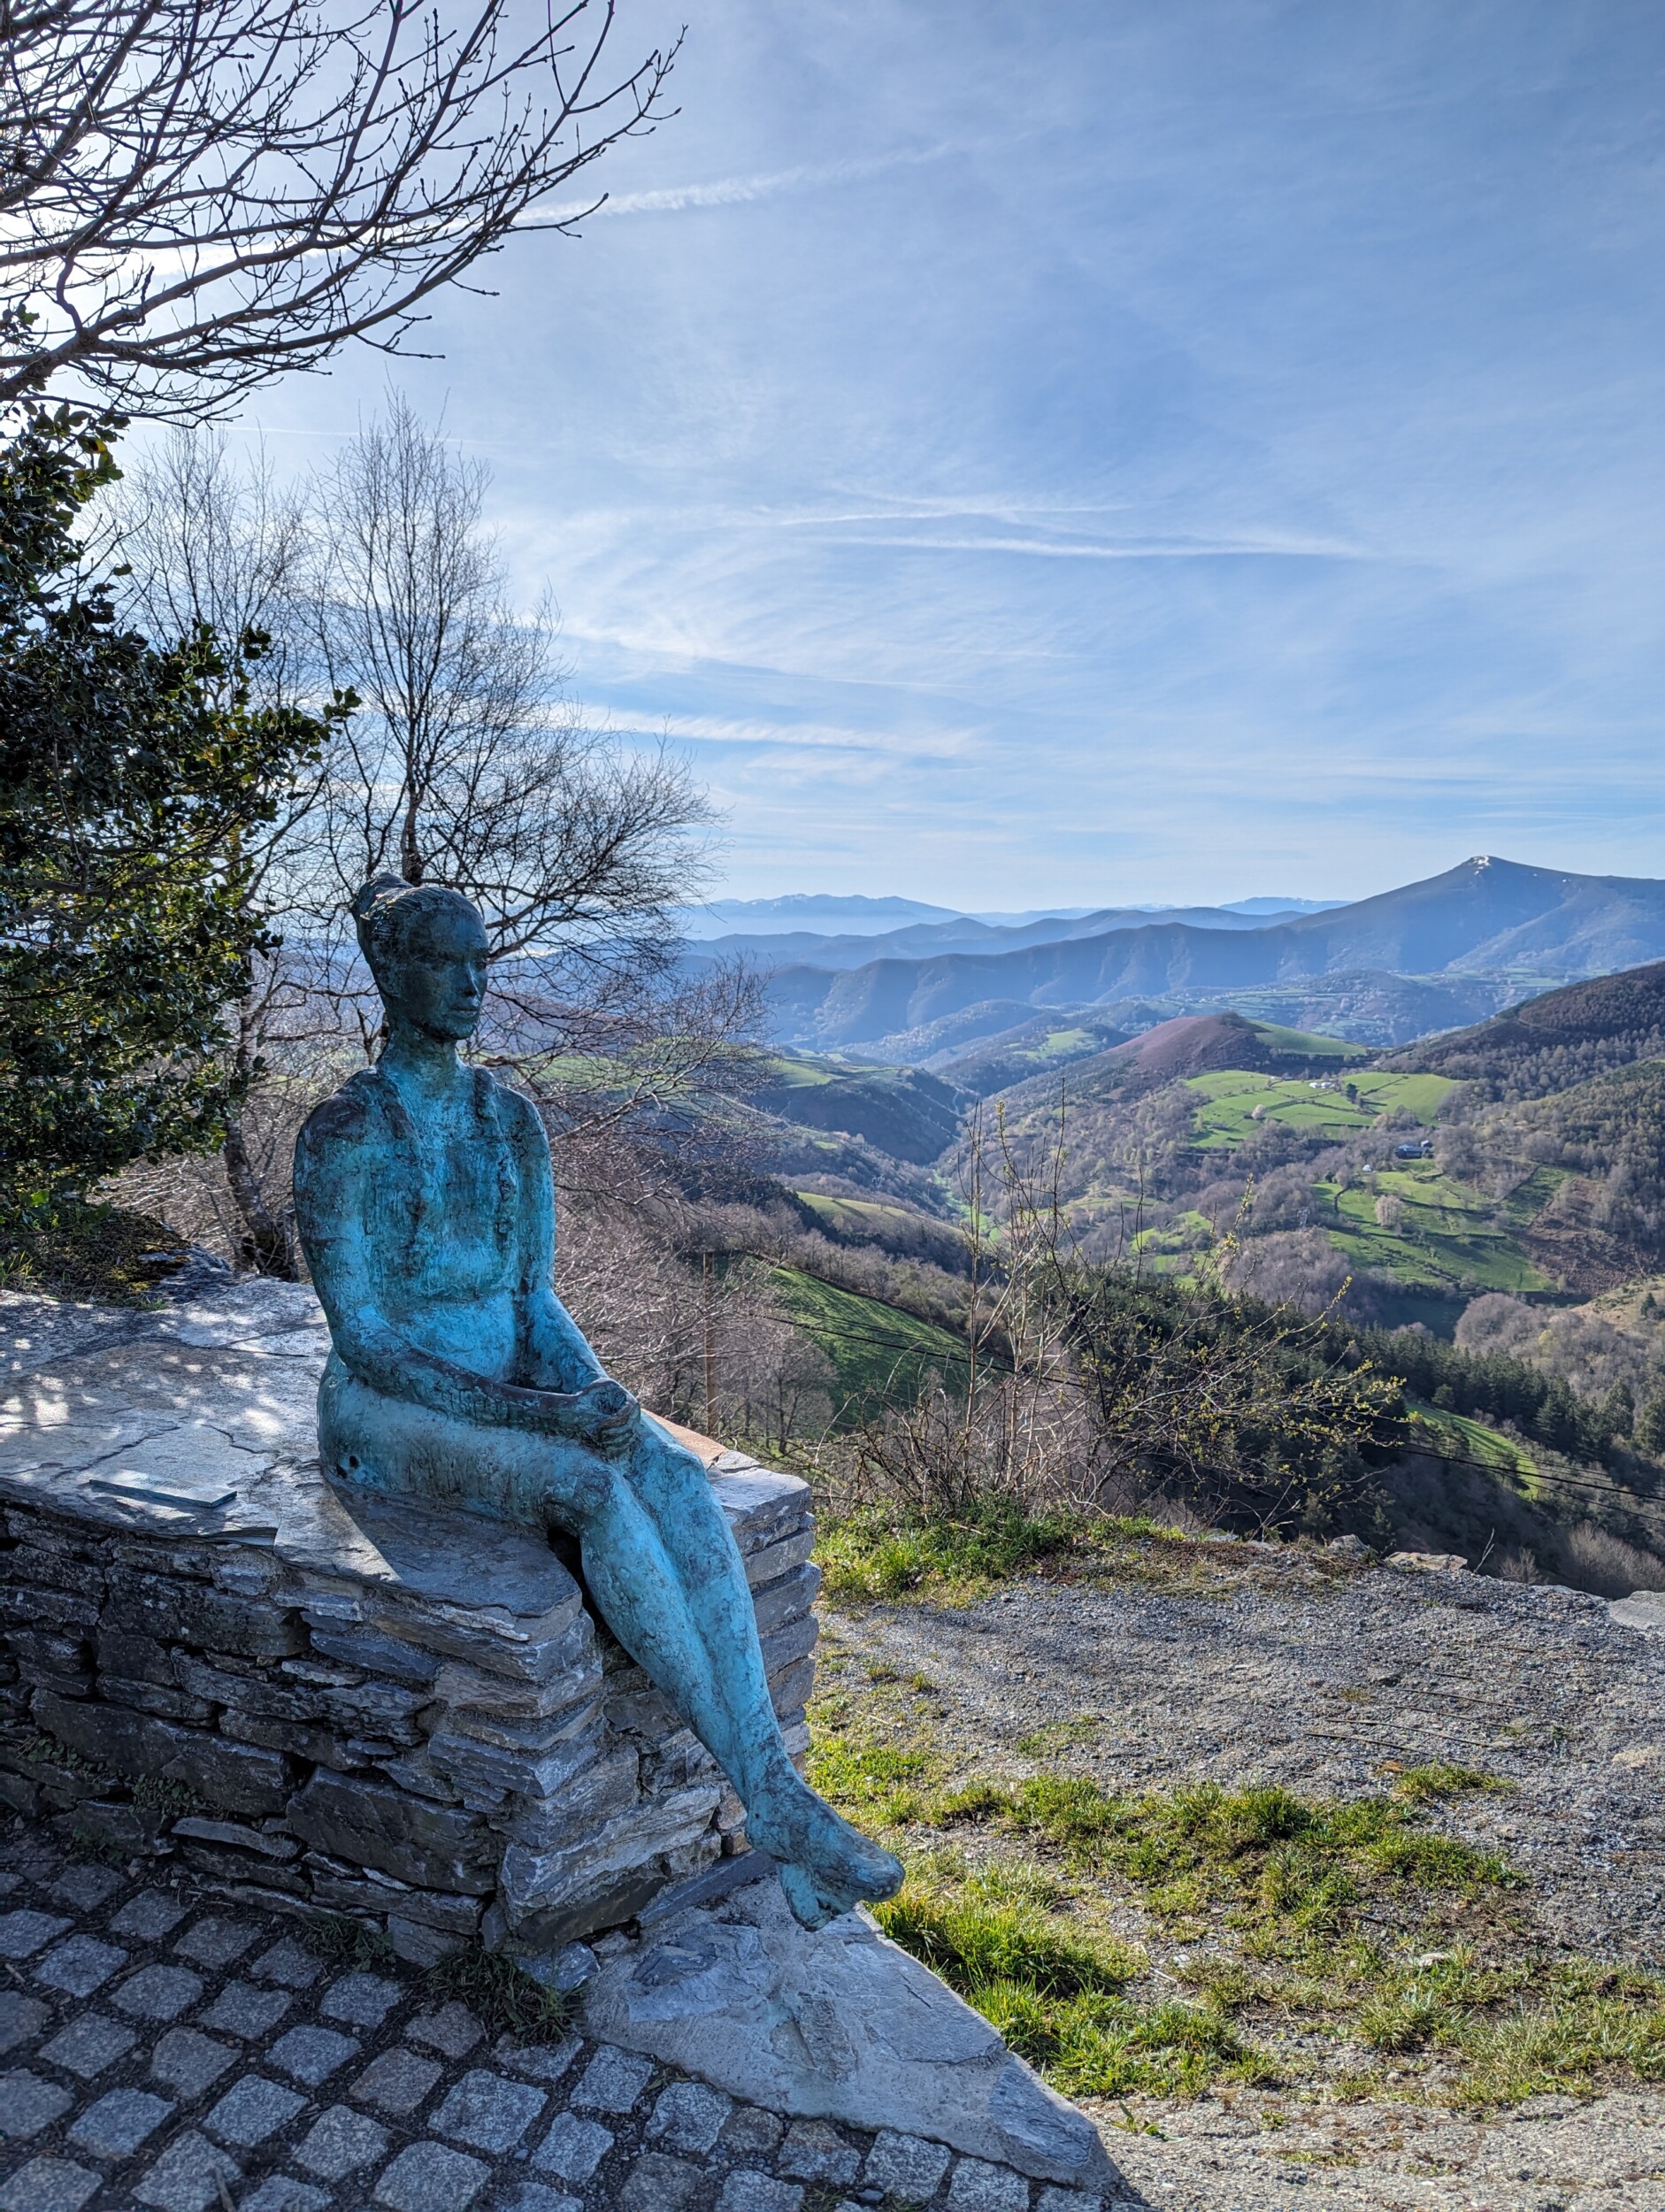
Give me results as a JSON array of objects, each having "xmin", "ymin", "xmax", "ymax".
[{"xmin": 809, "ymin": 1662, "xmax": 1665, "ymax": 2108}]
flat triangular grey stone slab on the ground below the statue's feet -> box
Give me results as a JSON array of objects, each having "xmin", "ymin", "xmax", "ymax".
[{"xmin": 584, "ymin": 1880, "xmax": 1115, "ymax": 2190}]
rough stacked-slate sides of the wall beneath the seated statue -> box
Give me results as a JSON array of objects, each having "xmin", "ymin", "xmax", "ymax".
[{"xmin": 0, "ymin": 1451, "xmax": 818, "ymax": 1962}]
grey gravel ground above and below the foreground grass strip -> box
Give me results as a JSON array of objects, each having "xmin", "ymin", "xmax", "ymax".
[{"xmin": 823, "ymin": 1547, "xmax": 1665, "ymax": 2212}]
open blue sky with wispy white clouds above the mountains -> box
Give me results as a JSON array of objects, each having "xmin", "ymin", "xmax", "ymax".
[{"xmin": 236, "ymin": 0, "xmax": 1665, "ymax": 907}]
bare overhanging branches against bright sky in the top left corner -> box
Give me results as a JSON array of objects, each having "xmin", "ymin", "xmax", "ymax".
[{"xmin": 0, "ymin": 0, "xmax": 674, "ymax": 419}]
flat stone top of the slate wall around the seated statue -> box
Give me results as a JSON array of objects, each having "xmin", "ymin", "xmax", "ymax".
[{"xmin": 0, "ymin": 1279, "xmax": 809, "ymax": 1635}]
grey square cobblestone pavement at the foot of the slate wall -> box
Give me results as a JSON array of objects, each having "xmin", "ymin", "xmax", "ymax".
[{"xmin": 0, "ymin": 1823, "xmax": 1123, "ymax": 2212}]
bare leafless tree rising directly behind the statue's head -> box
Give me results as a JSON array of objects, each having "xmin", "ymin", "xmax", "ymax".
[{"xmin": 314, "ymin": 398, "xmax": 710, "ymax": 1057}]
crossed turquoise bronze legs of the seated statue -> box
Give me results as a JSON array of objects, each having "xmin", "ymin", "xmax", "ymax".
[{"xmin": 318, "ymin": 1370, "xmax": 902, "ymax": 1924}]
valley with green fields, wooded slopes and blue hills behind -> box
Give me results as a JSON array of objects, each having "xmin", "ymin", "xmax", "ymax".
[{"xmin": 689, "ymin": 863, "xmax": 1665, "ymax": 1595}]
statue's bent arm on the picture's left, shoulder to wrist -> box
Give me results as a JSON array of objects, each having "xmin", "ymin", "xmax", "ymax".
[{"xmin": 294, "ymin": 1093, "xmax": 588, "ymax": 1433}]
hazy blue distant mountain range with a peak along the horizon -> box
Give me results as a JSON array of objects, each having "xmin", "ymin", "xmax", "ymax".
[{"xmin": 738, "ymin": 856, "xmax": 1665, "ymax": 1057}]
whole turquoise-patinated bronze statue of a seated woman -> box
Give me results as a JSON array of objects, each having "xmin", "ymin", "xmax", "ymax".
[{"xmin": 294, "ymin": 876, "xmax": 902, "ymax": 1927}]
